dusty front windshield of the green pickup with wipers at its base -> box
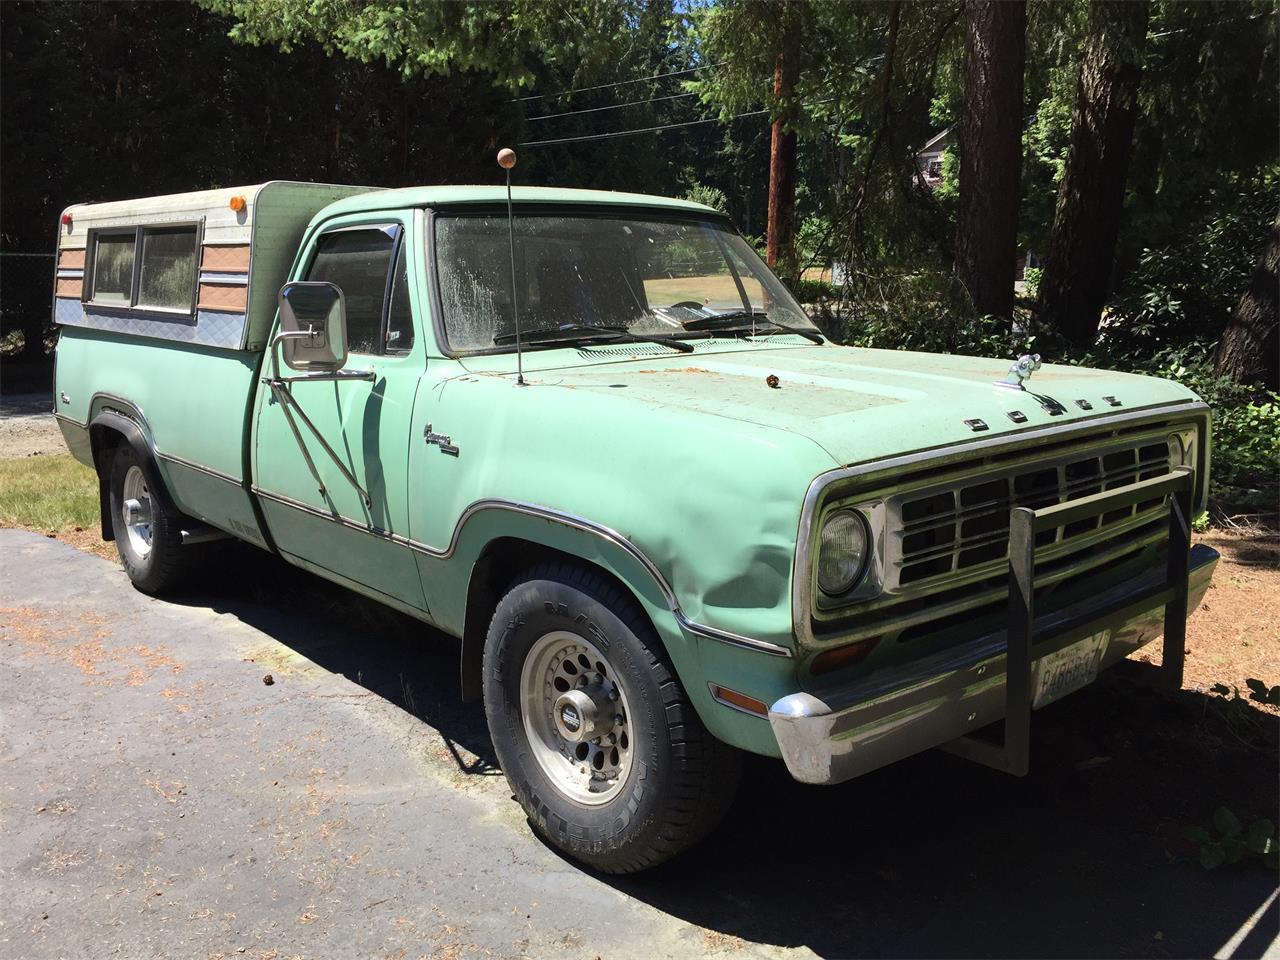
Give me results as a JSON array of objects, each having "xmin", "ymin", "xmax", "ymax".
[{"xmin": 435, "ymin": 212, "xmax": 814, "ymax": 352}]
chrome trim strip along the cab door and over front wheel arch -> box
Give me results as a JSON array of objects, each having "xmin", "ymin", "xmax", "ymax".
[{"xmin": 252, "ymin": 484, "xmax": 794, "ymax": 657}]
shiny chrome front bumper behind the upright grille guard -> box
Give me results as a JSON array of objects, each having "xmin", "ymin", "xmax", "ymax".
[{"xmin": 769, "ymin": 544, "xmax": 1219, "ymax": 783}]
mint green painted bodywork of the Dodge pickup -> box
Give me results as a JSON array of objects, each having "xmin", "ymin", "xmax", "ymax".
[{"xmin": 56, "ymin": 187, "xmax": 1194, "ymax": 755}]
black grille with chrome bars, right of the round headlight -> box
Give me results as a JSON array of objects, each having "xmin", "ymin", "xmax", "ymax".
[{"xmin": 886, "ymin": 436, "xmax": 1170, "ymax": 588}]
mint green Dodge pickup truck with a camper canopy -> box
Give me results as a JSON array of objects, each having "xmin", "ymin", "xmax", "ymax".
[{"xmin": 54, "ymin": 182, "xmax": 1217, "ymax": 872}]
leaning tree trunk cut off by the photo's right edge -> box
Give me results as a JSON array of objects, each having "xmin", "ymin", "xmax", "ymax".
[{"xmin": 1213, "ymin": 214, "xmax": 1280, "ymax": 390}]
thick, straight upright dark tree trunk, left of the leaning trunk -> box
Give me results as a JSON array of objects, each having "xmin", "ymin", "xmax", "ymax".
[{"xmin": 956, "ymin": 0, "xmax": 1027, "ymax": 317}]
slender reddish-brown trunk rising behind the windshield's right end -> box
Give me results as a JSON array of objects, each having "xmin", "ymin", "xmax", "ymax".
[{"xmin": 765, "ymin": 4, "xmax": 800, "ymax": 274}]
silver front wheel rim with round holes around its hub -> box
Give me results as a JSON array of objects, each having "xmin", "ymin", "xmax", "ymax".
[{"xmin": 520, "ymin": 630, "xmax": 632, "ymax": 805}]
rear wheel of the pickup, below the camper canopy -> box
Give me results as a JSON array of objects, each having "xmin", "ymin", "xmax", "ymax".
[{"xmin": 108, "ymin": 443, "xmax": 205, "ymax": 594}]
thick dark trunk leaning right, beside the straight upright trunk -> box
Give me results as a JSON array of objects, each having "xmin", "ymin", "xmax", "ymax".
[{"xmin": 1038, "ymin": 0, "xmax": 1147, "ymax": 347}]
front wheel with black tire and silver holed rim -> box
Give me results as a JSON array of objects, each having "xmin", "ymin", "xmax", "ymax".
[{"xmin": 484, "ymin": 563, "xmax": 740, "ymax": 873}]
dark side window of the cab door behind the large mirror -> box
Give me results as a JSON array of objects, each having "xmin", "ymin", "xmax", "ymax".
[{"xmin": 307, "ymin": 224, "xmax": 413, "ymax": 355}]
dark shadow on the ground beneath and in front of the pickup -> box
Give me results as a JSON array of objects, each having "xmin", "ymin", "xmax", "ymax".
[{"xmin": 175, "ymin": 547, "xmax": 1277, "ymax": 957}]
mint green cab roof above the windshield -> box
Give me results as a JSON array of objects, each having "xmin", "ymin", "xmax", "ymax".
[{"xmin": 312, "ymin": 184, "xmax": 723, "ymax": 223}]
